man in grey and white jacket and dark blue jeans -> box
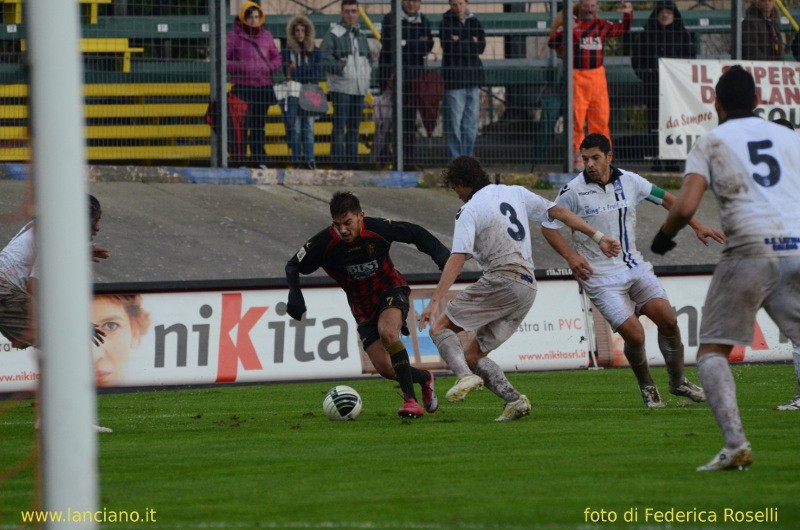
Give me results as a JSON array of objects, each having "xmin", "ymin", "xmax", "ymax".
[{"xmin": 322, "ymin": 0, "xmax": 373, "ymax": 169}]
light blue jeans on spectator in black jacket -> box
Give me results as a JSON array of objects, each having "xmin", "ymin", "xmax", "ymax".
[{"xmin": 444, "ymin": 87, "xmax": 481, "ymax": 159}]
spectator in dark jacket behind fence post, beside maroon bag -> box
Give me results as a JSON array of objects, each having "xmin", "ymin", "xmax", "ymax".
[{"xmin": 379, "ymin": 0, "xmax": 433, "ymax": 168}]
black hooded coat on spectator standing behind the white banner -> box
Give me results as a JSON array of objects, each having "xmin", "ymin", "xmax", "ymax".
[{"xmin": 631, "ymin": 0, "xmax": 695, "ymax": 78}]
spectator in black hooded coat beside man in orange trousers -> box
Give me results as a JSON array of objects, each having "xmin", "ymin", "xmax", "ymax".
[{"xmin": 631, "ymin": 0, "xmax": 695, "ymax": 171}]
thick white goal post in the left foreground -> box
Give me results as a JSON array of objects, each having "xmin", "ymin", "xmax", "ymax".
[{"xmin": 24, "ymin": 0, "xmax": 98, "ymax": 529}]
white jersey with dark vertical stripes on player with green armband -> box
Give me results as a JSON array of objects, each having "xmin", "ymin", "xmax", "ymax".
[{"xmin": 542, "ymin": 166, "xmax": 664, "ymax": 276}]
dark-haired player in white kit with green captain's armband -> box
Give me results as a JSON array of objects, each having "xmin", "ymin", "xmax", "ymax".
[{"xmin": 542, "ymin": 133, "xmax": 724, "ymax": 408}]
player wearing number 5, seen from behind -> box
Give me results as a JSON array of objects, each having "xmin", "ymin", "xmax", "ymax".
[{"xmin": 651, "ymin": 65, "xmax": 800, "ymax": 471}]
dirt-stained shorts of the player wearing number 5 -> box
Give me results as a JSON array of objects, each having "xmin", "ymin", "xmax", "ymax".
[{"xmin": 700, "ymin": 256, "xmax": 800, "ymax": 346}]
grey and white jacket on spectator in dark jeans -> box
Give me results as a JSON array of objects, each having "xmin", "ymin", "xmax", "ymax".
[{"xmin": 322, "ymin": 18, "xmax": 373, "ymax": 96}]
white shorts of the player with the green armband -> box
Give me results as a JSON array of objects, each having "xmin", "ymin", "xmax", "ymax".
[{"xmin": 581, "ymin": 262, "xmax": 668, "ymax": 331}]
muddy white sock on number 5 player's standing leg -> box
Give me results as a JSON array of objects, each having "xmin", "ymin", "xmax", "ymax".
[{"xmin": 697, "ymin": 353, "xmax": 747, "ymax": 449}]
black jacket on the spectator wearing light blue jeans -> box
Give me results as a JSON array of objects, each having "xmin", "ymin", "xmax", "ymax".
[{"xmin": 439, "ymin": 11, "xmax": 486, "ymax": 90}]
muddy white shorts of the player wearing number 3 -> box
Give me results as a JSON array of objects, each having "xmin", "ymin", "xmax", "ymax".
[{"xmin": 445, "ymin": 275, "xmax": 536, "ymax": 353}]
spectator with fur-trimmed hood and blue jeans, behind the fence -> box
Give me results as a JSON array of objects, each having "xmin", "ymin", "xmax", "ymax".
[{"xmin": 282, "ymin": 15, "xmax": 322, "ymax": 169}]
